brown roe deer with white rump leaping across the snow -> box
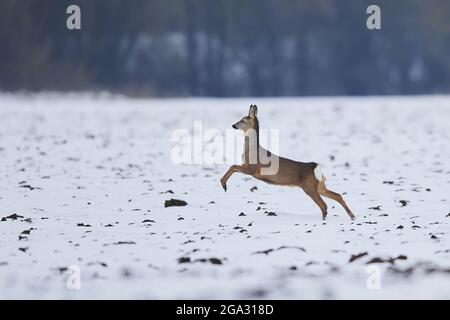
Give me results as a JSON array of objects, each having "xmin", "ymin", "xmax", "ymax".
[{"xmin": 220, "ymin": 105, "xmax": 356, "ymax": 220}]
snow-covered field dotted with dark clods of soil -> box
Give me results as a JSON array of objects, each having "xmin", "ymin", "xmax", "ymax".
[{"xmin": 0, "ymin": 94, "xmax": 450, "ymax": 299}]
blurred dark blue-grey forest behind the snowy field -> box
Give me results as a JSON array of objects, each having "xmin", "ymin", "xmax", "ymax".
[{"xmin": 0, "ymin": 0, "xmax": 450, "ymax": 97}]
